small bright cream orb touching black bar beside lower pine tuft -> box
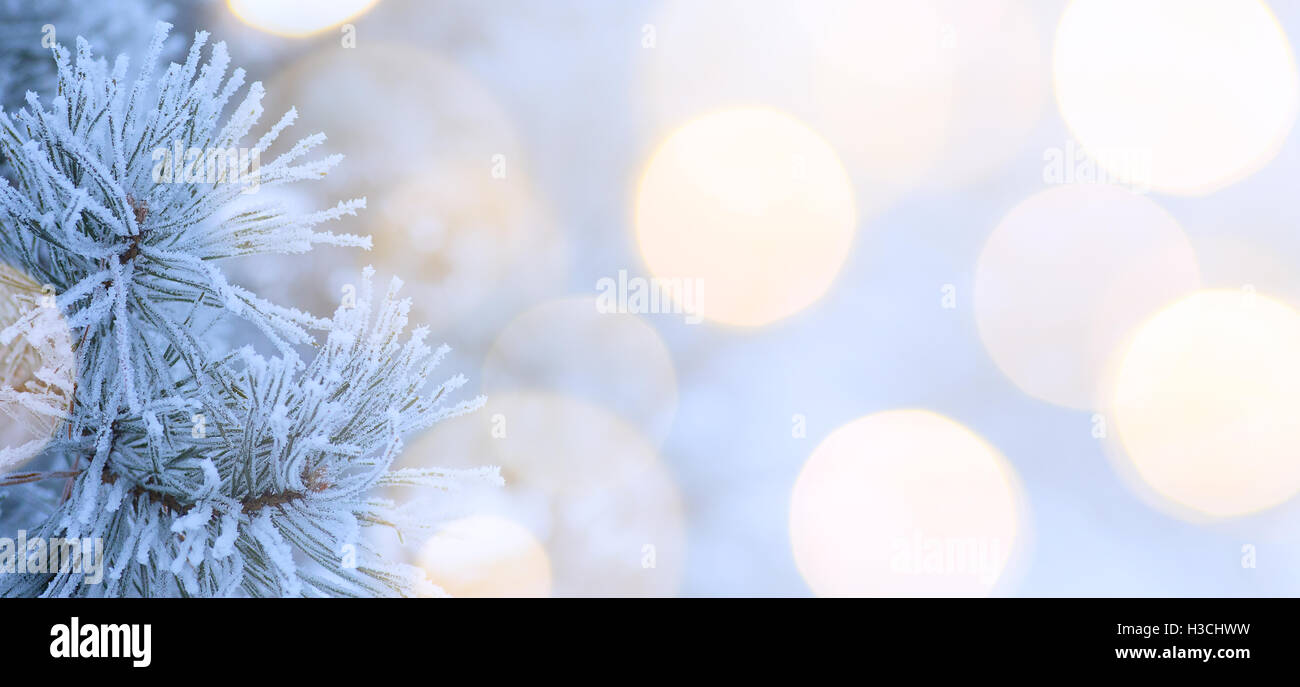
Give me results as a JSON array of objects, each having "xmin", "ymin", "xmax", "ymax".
[{"xmin": 419, "ymin": 515, "xmax": 551, "ymax": 597}]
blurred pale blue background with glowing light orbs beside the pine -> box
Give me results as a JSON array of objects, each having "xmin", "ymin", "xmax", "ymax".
[{"xmin": 15, "ymin": 0, "xmax": 1300, "ymax": 596}]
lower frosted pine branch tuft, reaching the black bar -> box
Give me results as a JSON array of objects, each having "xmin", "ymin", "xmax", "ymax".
[{"xmin": 0, "ymin": 269, "xmax": 499, "ymax": 596}]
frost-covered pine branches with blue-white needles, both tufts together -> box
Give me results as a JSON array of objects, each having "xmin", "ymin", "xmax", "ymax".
[{"xmin": 0, "ymin": 23, "xmax": 499, "ymax": 596}]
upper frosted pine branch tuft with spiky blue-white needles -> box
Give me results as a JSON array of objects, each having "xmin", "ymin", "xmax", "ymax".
[{"xmin": 0, "ymin": 25, "xmax": 369, "ymax": 418}]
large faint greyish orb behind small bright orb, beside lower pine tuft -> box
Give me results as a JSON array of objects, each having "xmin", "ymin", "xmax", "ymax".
[{"xmin": 398, "ymin": 392, "xmax": 685, "ymax": 596}]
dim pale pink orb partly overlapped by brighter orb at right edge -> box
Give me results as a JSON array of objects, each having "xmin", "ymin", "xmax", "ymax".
[{"xmin": 974, "ymin": 183, "xmax": 1200, "ymax": 410}]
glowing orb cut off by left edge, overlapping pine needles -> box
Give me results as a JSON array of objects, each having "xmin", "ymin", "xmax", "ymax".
[{"xmin": 0, "ymin": 263, "xmax": 77, "ymax": 474}]
